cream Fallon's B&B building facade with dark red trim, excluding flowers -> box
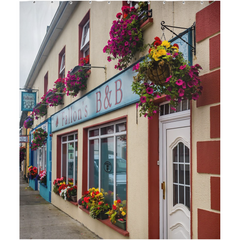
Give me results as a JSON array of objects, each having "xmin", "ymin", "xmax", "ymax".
[{"xmin": 19, "ymin": 1, "xmax": 220, "ymax": 239}]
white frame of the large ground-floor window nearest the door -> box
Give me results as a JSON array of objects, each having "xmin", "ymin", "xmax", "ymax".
[{"xmin": 87, "ymin": 119, "xmax": 127, "ymax": 201}]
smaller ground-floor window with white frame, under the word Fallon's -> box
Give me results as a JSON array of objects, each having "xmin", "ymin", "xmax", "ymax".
[{"xmin": 61, "ymin": 133, "xmax": 78, "ymax": 185}]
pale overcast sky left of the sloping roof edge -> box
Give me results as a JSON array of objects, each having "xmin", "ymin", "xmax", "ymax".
[{"xmin": 19, "ymin": 1, "xmax": 59, "ymax": 120}]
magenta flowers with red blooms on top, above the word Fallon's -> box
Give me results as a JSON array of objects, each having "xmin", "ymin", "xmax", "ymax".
[{"xmin": 64, "ymin": 56, "xmax": 90, "ymax": 97}]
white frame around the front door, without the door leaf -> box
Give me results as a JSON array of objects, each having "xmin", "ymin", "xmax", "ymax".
[{"xmin": 159, "ymin": 109, "xmax": 191, "ymax": 239}]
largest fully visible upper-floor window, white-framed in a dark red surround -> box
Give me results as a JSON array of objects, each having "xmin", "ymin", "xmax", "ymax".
[{"xmin": 79, "ymin": 11, "xmax": 90, "ymax": 61}]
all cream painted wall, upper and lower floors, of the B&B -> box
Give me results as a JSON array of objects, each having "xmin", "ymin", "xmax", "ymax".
[{"xmin": 28, "ymin": 1, "xmax": 214, "ymax": 238}]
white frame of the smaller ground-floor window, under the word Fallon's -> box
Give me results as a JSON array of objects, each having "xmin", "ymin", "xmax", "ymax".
[{"xmin": 60, "ymin": 132, "xmax": 78, "ymax": 186}]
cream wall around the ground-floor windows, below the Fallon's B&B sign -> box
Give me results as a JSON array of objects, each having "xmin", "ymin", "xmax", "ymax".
[{"xmin": 52, "ymin": 105, "xmax": 148, "ymax": 239}]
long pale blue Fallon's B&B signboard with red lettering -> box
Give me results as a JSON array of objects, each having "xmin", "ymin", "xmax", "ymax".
[{"xmin": 52, "ymin": 67, "xmax": 139, "ymax": 132}]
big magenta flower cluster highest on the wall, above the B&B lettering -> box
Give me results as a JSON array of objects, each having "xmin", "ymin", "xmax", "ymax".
[{"xmin": 103, "ymin": 4, "xmax": 146, "ymax": 70}]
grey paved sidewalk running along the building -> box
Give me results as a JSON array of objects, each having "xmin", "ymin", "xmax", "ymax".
[{"xmin": 19, "ymin": 174, "xmax": 100, "ymax": 239}]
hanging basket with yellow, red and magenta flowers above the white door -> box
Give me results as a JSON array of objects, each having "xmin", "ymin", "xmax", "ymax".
[{"xmin": 132, "ymin": 37, "xmax": 203, "ymax": 119}]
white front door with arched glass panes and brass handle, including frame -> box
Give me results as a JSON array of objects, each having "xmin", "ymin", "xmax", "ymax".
[{"xmin": 159, "ymin": 106, "xmax": 190, "ymax": 239}]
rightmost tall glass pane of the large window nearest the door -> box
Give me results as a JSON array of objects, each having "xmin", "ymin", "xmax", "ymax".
[{"xmin": 116, "ymin": 135, "xmax": 127, "ymax": 202}]
